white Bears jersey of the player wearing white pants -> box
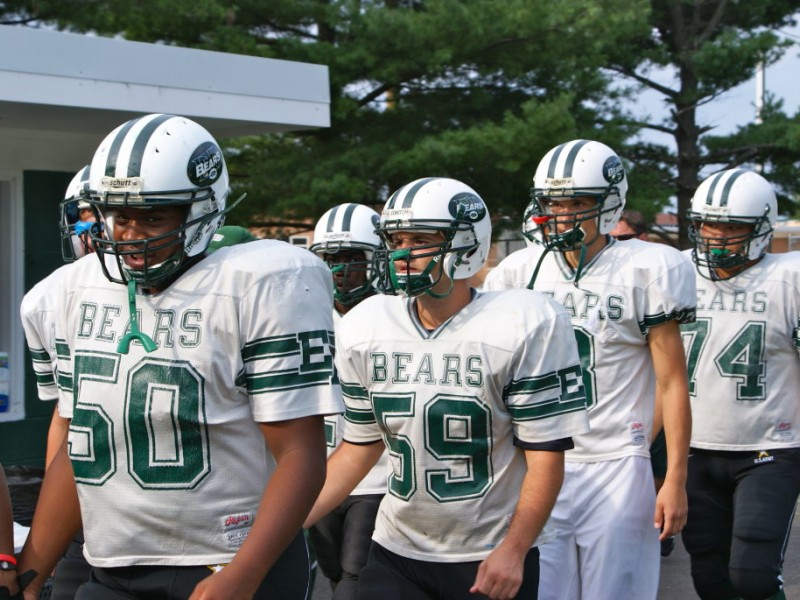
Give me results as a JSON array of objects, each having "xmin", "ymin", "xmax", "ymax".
[{"xmin": 484, "ymin": 240, "xmax": 695, "ymax": 462}]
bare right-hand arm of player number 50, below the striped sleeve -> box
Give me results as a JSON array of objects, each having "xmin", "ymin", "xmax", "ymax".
[{"xmin": 190, "ymin": 415, "xmax": 326, "ymax": 600}]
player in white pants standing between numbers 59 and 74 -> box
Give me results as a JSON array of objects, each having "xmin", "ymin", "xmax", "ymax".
[{"xmin": 484, "ymin": 140, "xmax": 695, "ymax": 600}]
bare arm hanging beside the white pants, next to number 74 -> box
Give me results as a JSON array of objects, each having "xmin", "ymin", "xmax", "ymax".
[{"xmin": 647, "ymin": 321, "xmax": 692, "ymax": 540}]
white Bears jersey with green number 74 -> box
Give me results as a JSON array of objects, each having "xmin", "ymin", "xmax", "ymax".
[{"xmin": 681, "ymin": 251, "xmax": 800, "ymax": 451}]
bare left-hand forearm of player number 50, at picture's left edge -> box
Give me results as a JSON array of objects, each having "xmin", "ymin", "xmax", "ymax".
[{"xmin": 18, "ymin": 438, "xmax": 81, "ymax": 599}]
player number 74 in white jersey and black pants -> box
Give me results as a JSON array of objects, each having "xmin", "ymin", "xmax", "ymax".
[{"xmin": 682, "ymin": 169, "xmax": 800, "ymax": 599}]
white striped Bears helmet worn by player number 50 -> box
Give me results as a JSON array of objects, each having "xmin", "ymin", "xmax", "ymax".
[{"xmin": 87, "ymin": 114, "xmax": 232, "ymax": 287}]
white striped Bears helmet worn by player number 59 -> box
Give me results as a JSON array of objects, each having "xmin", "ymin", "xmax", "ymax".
[{"xmin": 378, "ymin": 177, "xmax": 492, "ymax": 297}]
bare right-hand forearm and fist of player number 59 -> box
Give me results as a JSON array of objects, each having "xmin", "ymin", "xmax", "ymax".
[{"xmin": 470, "ymin": 450, "xmax": 564, "ymax": 600}]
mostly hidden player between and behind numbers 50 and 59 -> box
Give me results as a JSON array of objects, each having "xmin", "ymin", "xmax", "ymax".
[{"xmin": 308, "ymin": 203, "xmax": 389, "ymax": 600}]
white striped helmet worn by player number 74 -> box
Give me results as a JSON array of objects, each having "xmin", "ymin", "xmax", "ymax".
[{"xmin": 687, "ymin": 169, "xmax": 778, "ymax": 280}]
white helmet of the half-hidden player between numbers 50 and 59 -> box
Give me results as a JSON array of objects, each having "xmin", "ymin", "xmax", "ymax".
[{"xmin": 309, "ymin": 203, "xmax": 381, "ymax": 306}]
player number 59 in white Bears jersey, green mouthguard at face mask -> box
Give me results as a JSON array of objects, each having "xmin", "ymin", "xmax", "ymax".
[{"xmin": 307, "ymin": 177, "xmax": 587, "ymax": 600}]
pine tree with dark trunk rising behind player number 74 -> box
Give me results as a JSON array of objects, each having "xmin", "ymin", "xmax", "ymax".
[{"xmin": 609, "ymin": 0, "xmax": 800, "ymax": 248}]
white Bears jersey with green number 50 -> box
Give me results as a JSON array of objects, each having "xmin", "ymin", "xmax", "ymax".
[{"xmin": 56, "ymin": 240, "xmax": 344, "ymax": 567}]
